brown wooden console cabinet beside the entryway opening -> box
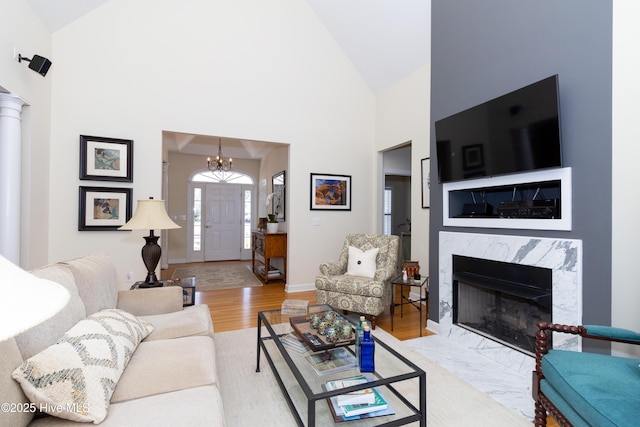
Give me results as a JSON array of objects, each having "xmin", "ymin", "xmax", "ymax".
[{"xmin": 251, "ymin": 231, "xmax": 287, "ymax": 283}]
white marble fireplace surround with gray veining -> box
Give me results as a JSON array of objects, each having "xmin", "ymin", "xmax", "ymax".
[{"xmin": 438, "ymin": 231, "xmax": 582, "ymax": 374}]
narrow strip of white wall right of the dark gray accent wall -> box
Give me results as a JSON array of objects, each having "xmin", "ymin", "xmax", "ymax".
[{"xmin": 611, "ymin": 2, "xmax": 640, "ymax": 357}]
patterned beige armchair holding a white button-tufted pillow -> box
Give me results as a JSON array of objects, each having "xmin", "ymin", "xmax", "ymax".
[{"xmin": 316, "ymin": 234, "xmax": 399, "ymax": 329}]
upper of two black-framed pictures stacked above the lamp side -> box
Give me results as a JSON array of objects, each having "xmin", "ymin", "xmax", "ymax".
[{"xmin": 80, "ymin": 135, "xmax": 133, "ymax": 182}]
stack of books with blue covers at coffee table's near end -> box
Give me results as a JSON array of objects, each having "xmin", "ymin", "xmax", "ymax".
[{"xmin": 325, "ymin": 375, "xmax": 395, "ymax": 422}]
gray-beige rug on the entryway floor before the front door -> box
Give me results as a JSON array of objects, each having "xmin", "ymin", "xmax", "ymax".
[{"xmin": 172, "ymin": 262, "xmax": 262, "ymax": 291}]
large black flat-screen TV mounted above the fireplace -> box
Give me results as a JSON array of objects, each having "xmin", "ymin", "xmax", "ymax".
[{"xmin": 435, "ymin": 75, "xmax": 562, "ymax": 183}]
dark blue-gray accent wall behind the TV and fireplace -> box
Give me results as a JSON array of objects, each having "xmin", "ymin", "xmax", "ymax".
[{"xmin": 429, "ymin": 0, "xmax": 612, "ymax": 352}]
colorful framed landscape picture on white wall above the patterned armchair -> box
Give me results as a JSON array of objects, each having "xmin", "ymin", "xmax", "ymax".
[{"xmin": 310, "ymin": 173, "xmax": 351, "ymax": 211}]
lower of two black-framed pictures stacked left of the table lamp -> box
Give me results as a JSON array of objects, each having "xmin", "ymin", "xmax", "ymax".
[{"xmin": 78, "ymin": 187, "xmax": 132, "ymax": 231}]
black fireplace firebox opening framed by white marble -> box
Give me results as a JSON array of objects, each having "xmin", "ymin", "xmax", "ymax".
[{"xmin": 453, "ymin": 255, "xmax": 552, "ymax": 355}]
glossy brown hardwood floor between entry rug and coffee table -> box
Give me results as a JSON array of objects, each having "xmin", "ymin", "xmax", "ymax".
[{"xmin": 160, "ymin": 261, "xmax": 558, "ymax": 427}]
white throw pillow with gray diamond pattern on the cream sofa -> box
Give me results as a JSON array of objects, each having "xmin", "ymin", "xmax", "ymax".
[{"xmin": 12, "ymin": 309, "xmax": 153, "ymax": 424}]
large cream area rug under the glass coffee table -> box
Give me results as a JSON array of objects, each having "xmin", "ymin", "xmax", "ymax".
[{"xmin": 214, "ymin": 326, "xmax": 531, "ymax": 427}]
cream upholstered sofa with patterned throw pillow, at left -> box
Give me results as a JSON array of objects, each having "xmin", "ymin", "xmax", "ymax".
[{"xmin": 0, "ymin": 254, "xmax": 225, "ymax": 427}]
